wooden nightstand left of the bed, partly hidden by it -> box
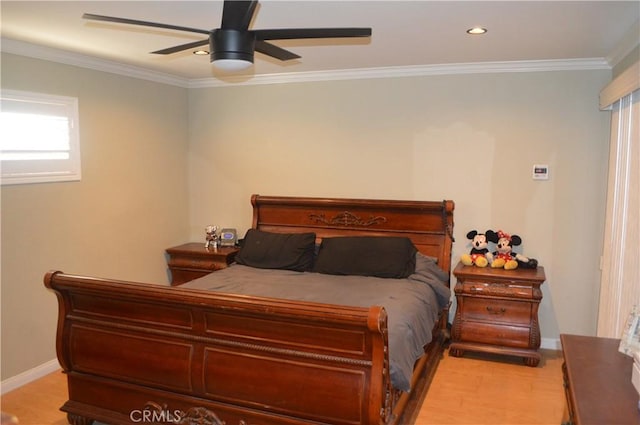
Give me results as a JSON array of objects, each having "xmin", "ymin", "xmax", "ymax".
[{"xmin": 167, "ymin": 242, "xmax": 239, "ymax": 286}]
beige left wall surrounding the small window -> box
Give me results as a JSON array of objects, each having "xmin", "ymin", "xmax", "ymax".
[{"xmin": 1, "ymin": 54, "xmax": 188, "ymax": 380}]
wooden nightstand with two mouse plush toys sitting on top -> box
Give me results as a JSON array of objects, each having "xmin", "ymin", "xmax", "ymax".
[{"xmin": 449, "ymin": 263, "xmax": 546, "ymax": 366}]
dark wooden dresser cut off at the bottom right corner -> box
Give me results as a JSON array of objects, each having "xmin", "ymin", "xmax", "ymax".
[{"xmin": 560, "ymin": 334, "xmax": 640, "ymax": 425}]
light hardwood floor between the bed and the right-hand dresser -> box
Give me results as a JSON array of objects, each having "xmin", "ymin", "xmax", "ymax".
[{"xmin": 416, "ymin": 350, "xmax": 566, "ymax": 425}]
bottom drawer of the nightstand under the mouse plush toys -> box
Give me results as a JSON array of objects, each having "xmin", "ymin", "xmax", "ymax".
[{"xmin": 459, "ymin": 322, "xmax": 531, "ymax": 348}]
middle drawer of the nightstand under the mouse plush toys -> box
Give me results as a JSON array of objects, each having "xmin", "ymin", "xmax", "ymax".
[{"xmin": 463, "ymin": 297, "xmax": 531, "ymax": 326}]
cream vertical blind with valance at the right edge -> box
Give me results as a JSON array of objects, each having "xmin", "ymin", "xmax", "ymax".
[{"xmin": 597, "ymin": 62, "xmax": 640, "ymax": 338}]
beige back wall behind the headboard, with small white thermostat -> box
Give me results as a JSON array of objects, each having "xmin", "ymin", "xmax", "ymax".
[{"xmin": 189, "ymin": 71, "xmax": 611, "ymax": 341}]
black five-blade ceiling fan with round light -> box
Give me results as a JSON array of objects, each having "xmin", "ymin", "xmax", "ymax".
[{"xmin": 82, "ymin": 0, "xmax": 371, "ymax": 71}]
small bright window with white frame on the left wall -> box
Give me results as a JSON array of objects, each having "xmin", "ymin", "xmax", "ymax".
[{"xmin": 0, "ymin": 90, "xmax": 80, "ymax": 185}]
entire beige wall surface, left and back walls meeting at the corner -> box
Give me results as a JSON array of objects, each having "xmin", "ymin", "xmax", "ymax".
[{"xmin": 1, "ymin": 51, "xmax": 611, "ymax": 379}]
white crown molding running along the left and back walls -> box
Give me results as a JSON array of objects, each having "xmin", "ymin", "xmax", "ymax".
[{"xmin": 0, "ymin": 38, "xmax": 611, "ymax": 88}]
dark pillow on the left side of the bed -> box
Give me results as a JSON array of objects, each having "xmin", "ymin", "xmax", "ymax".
[{"xmin": 235, "ymin": 229, "xmax": 316, "ymax": 272}]
